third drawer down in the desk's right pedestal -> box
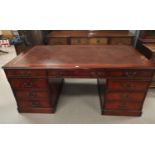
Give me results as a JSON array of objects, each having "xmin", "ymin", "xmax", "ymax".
[{"xmin": 105, "ymin": 92, "xmax": 145, "ymax": 102}]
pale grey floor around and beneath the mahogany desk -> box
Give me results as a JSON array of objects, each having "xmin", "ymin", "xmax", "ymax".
[{"xmin": 0, "ymin": 46, "xmax": 155, "ymax": 124}]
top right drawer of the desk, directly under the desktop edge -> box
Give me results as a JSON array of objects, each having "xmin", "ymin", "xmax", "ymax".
[{"xmin": 109, "ymin": 70, "xmax": 153, "ymax": 78}]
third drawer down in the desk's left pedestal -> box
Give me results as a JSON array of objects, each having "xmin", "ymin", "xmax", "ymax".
[{"xmin": 15, "ymin": 91, "xmax": 49, "ymax": 100}]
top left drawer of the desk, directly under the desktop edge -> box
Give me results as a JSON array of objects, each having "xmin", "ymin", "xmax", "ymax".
[{"xmin": 5, "ymin": 69, "xmax": 46, "ymax": 78}]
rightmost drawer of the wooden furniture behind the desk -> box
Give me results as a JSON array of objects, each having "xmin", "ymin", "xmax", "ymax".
[{"xmin": 110, "ymin": 38, "xmax": 132, "ymax": 45}]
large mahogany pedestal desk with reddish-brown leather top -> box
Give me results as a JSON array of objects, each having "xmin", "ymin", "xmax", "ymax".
[{"xmin": 3, "ymin": 45, "xmax": 155, "ymax": 116}]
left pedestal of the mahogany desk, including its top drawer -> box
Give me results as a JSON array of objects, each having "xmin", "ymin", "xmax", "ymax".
[{"xmin": 5, "ymin": 69, "xmax": 63, "ymax": 113}]
